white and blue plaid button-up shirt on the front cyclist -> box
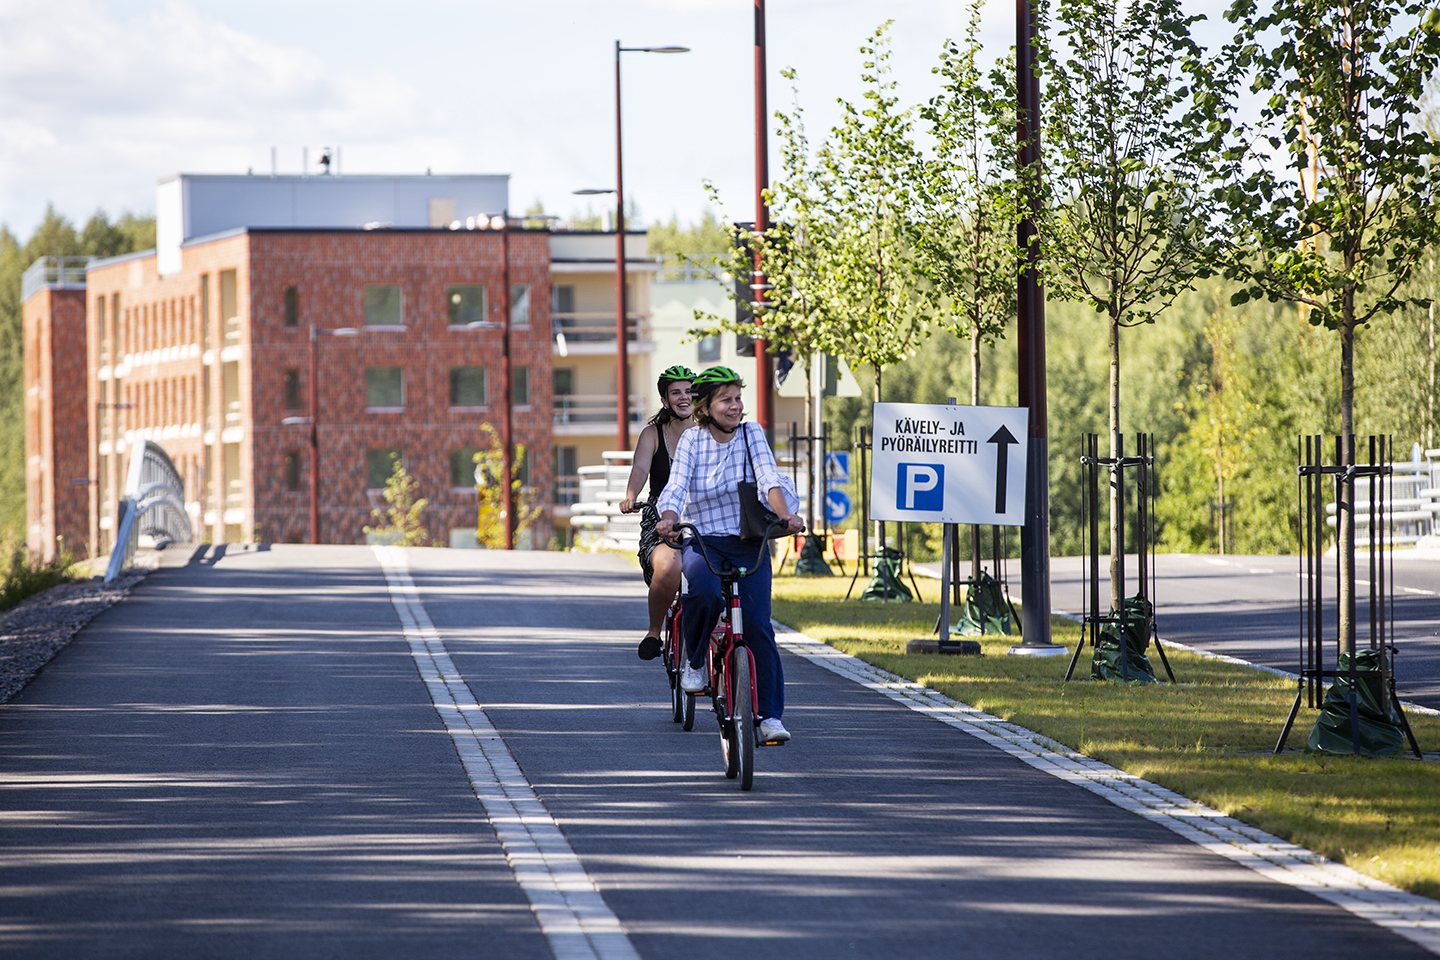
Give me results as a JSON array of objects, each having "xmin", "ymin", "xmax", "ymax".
[{"xmin": 655, "ymin": 423, "xmax": 799, "ymax": 537}]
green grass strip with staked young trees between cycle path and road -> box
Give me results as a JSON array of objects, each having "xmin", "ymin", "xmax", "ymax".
[{"xmin": 775, "ymin": 577, "xmax": 1440, "ymax": 900}]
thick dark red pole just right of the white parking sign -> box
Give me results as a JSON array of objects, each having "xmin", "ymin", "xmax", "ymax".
[{"xmin": 1011, "ymin": 0, "xmax": 1066, "ymax": 656}]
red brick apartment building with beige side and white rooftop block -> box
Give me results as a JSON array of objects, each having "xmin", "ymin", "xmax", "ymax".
[{"xmin": 23, "ymin": 174, "xmax": 655, "ymax": 556}]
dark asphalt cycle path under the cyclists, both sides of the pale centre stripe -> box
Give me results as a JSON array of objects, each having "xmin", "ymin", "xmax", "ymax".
[{"xmin": 0, "ymin": 545, "xmax": 1430, "ymax": 960}]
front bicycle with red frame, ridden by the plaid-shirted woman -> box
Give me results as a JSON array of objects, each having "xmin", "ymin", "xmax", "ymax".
[{"xmin": 674, "ymin": 522, "xmax": 785, "ymax": 790}]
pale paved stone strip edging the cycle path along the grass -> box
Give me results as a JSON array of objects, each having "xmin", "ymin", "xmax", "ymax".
[{"xmin": 775, "ymin": 623, "xmax": 1440, "ymax": 954}]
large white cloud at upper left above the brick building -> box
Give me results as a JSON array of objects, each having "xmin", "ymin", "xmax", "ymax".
[{"xmin": 0, "ymin": 0, "xmax": 441, "ymax": 230}]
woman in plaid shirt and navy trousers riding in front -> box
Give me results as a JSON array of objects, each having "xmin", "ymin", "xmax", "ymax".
[{"xmin": 655, "ymin": 367, "xmax": 805, "ymax": 743}]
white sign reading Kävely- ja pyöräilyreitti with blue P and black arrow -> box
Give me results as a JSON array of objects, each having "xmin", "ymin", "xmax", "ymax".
[{"xmin": 870, "ymin": 403, "xmax": 1030, "ymax": 527}]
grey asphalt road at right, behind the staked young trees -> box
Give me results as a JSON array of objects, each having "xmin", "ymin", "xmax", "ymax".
[{"xmin": 1048, "ymin": 551, "xmax": 1440, "ymax": 710}]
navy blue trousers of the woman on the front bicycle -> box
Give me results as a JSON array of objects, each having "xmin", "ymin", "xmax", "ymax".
[{"xmin": 681, "ymin": 537, "xmax": 785, "ymax": 720}]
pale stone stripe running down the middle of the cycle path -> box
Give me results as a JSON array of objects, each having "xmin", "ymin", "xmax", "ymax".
[{"xmin": 373, "ymin": 547, "xmax": 639, "ymax": 960}]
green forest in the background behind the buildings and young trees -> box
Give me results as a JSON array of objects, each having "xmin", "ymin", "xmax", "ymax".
[{"xmin": 0, "ymin": 210, "xmax": 1440, "ymax": 556}]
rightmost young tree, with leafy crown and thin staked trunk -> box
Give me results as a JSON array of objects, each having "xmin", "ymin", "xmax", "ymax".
[{"xmin": 1211, "ymin": 0, "xmax": 1440, "ymax": 651}]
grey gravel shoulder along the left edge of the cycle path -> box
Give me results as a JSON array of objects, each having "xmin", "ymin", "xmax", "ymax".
[{"xmin": 0, "ymin": 553, "xmax": 160, "ymax": 704}]
